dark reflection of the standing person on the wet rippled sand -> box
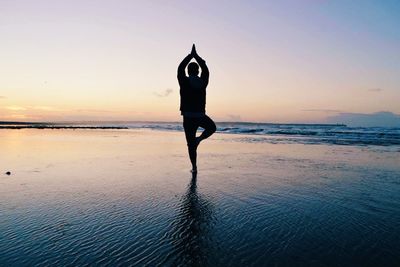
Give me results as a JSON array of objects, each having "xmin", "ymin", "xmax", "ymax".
[{"xmin": 172, "ymin": 173, "xmax": 216, "ymax": 266}]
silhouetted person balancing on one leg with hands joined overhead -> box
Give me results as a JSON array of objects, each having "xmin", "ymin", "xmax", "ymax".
[{"xmin": 178, "ymin": 44, "xmax": 217, "ymax": 173}]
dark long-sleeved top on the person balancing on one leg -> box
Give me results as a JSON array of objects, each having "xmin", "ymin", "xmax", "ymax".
[{"xmin": 178, "ymin": 54, "xmax": 209, "ymax": 115}]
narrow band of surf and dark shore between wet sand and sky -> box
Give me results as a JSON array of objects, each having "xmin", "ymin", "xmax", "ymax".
[{"xmin": 0, "ymin": 126, "xmax": 400, "ymax": 148}]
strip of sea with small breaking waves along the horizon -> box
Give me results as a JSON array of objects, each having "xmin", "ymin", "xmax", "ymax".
[{"xmin": 0, "ymin": 122, "xmax": 400, "ymax": 146}]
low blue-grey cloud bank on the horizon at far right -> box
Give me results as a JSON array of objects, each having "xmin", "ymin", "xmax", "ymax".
[{"xmin": 327, "ymin": 111, "xmax": 400, "ymax": 127}]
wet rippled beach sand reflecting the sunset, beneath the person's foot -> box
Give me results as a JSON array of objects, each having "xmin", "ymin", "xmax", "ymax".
[{"xmin": 0, "ymin": 129, "xmax": 400, "ymax": 266}]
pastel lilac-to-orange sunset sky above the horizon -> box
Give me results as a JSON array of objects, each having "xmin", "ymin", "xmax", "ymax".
[{"xmin": 0, "ymin": 0, "xmax": 400, "ymax": 123}]
